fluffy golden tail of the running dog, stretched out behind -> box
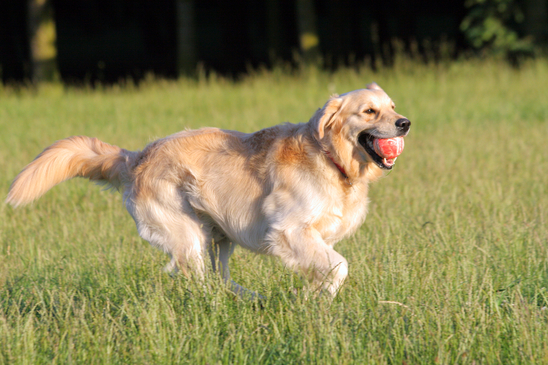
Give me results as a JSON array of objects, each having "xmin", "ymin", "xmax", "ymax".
[{"xmin": 6, "ymin": 136, "xmax": 137, "ymax": 206}]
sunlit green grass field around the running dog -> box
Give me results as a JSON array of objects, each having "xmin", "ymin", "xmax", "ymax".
[{"xmin": 0, "ymin": 59, "xmax": 548, "ymax": 364}]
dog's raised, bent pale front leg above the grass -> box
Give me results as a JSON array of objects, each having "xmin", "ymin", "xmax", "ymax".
[{"xmin": 270, "ymin": 227, "xmax": 348, "ymax": 297}]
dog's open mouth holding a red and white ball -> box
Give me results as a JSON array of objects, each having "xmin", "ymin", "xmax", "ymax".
[{"xmin": 358, "ymin": 132, "xmax": 404, "ymax": 170}]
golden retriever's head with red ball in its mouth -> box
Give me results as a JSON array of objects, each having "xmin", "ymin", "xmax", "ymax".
[{"xmin": 313, "ymin": 83, "xmax": 411, "ymax": 170}]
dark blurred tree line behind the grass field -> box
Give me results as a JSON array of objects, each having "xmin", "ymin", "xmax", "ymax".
[{"xmin": 0, "ymin": 0, "xmax": 548, "ymax": 83}]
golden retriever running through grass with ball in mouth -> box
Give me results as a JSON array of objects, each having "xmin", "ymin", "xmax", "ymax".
[{"xmin": 6, "ymin": 83, "xmax": 411, "ymax": 297}]
